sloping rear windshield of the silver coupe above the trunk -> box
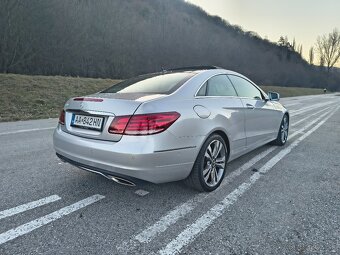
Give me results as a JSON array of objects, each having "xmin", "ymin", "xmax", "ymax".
[{"xmin": 101, "ymin": 72, "xmax": 195, "ymax": 94}]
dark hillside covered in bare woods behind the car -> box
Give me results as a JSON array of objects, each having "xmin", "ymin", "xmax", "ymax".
[{"xmin": 0, "ymin": 0, "xmax": 340, "ymax": 90}]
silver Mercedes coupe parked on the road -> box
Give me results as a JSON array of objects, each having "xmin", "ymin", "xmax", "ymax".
[{"xmin": 53, "ymin": 66, "xmax": 289, "ymax": 191}]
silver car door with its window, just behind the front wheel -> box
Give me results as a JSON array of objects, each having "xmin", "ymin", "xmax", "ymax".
[{"xmin": 228, "ymin": 75, "xmax": 278, "ymax": 148}]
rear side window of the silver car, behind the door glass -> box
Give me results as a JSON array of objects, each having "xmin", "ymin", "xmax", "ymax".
[{"xmin": 197, "ymin": 75, "xmax": 237, "ymax": 96}]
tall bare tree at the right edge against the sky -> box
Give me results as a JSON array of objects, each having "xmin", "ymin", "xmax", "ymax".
[{"xmin": 316, "ymin": 28, "xmax": 340, "ymax": 74}]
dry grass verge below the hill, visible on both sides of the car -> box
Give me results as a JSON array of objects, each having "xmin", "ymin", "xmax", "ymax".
[{"xmin": 0, "ymin": 74, "xmax": 323, "ymax": 122}]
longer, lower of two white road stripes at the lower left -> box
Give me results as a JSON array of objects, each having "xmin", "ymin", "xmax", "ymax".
[{"xmin": 0, "ymin": 194, "xmax": 105, "ymax": 245}]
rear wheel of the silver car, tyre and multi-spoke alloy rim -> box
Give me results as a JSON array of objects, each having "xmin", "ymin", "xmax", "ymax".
[{"xmin": 184, "ymin": 134, "xmax": 229, "ymax": 192}]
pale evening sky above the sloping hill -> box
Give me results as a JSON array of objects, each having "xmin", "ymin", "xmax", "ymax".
[{"xmin": 187, "ymin": 0, "xmax": 340, "ymax": 66}]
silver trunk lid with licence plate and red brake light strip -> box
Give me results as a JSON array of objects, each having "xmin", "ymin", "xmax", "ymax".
[{"xmin": 62, "ymin": 93, "xmax": 165, "ymax": 142}]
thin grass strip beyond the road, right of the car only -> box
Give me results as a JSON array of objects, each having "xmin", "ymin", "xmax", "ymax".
[{"xmin": 261, "ymin": 86, "xmax": 324, "ymax": 97}]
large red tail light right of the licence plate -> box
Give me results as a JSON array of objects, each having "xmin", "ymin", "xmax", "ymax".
[{"xmin": 109, "ymin": 112, "xmax": 181, "ymax": 135}]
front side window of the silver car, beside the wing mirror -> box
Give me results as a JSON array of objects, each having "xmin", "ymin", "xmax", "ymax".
[{"xmin": 228, "ymin": 75, "xmax": 262, "ymax": 99}]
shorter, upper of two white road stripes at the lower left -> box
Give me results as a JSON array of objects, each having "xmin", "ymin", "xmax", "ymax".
[{"xmin": 0, "ymin": 195, "xmax": 61, "ymax": 220}]
